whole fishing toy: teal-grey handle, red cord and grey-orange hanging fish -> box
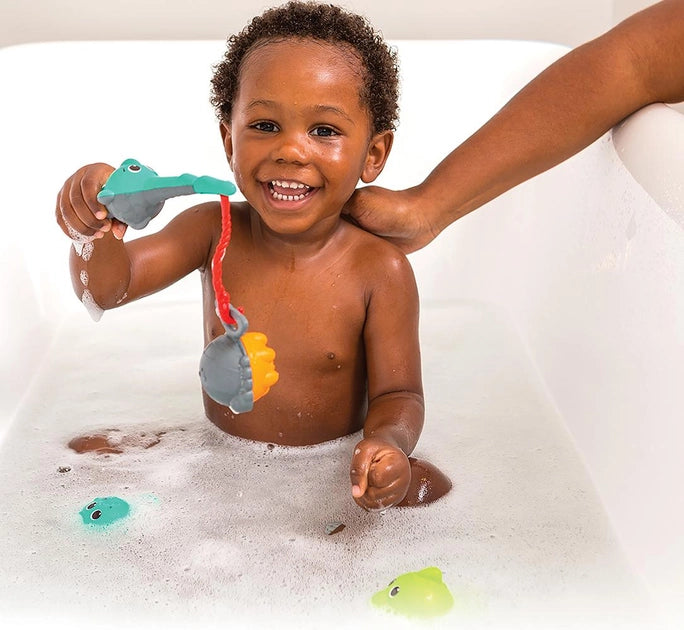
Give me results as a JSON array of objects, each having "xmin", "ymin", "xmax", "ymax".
[{"xmin": 97, "ymin": 159, "xmax": 278, "ymax": 413}]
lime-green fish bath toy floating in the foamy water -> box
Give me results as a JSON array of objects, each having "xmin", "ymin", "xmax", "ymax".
[{"xmin": 371, "ymin": 567, "xmax": 454, "ymax": 619}]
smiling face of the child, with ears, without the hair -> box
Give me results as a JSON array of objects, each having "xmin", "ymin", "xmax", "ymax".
[{"xmin": 222, "ymin": 39, "xmax": 392, "ymax": 235}]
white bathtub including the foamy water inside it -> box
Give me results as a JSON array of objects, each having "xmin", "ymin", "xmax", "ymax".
[{"xmin": 0, "ymin": 41, "xmax": 684, "ymax": 628}]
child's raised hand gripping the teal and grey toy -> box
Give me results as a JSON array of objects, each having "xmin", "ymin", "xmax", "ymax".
[{"xmin": 55, "ymin": 163, "xmax": 127, "ymax": 241}]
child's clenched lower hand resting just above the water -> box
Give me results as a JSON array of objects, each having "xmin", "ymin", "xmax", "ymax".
[{"xmin": 351, "ymin": 438, "xmax": 411, "ymax": 510}]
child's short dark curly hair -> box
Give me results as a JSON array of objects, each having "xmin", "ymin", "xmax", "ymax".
[{"xmin": 211, "ymin": 1, "xmax": 399, "ymax": 133}]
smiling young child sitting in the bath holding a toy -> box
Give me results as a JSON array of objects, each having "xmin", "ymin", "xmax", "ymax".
[{"xmin": 57, "ymin": 2, "xmax": 450, "ymax": 510}]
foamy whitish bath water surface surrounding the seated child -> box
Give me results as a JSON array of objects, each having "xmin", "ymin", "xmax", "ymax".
[{"xmin": 0, "ymin": 304, "xmax": 652, "ymax": 629}]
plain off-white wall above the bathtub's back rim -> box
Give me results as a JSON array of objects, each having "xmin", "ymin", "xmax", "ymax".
[{"xmin": 0, "ymin": 0, "xmax": 653, "ymax": 47}]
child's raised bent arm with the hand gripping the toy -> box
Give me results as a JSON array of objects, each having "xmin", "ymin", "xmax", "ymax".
[{"xmin": 56, "ymin": 164, "xmax": 220, "ymax": 309}]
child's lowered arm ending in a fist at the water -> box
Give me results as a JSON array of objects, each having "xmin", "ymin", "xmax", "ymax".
[{"xmin": 351, "ymin": 244, "xmax": 425, "ymax": 510}]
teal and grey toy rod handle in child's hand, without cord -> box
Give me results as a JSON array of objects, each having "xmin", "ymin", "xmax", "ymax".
[{"xmin": 97, "ymin": 159, "xmax": 236, "ymax": 230}]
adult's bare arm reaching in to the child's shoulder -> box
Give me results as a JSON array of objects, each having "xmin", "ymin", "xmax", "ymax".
[{"xmin": 346, "ymin": 0, "xmax": 684, "ymax": 252}]
